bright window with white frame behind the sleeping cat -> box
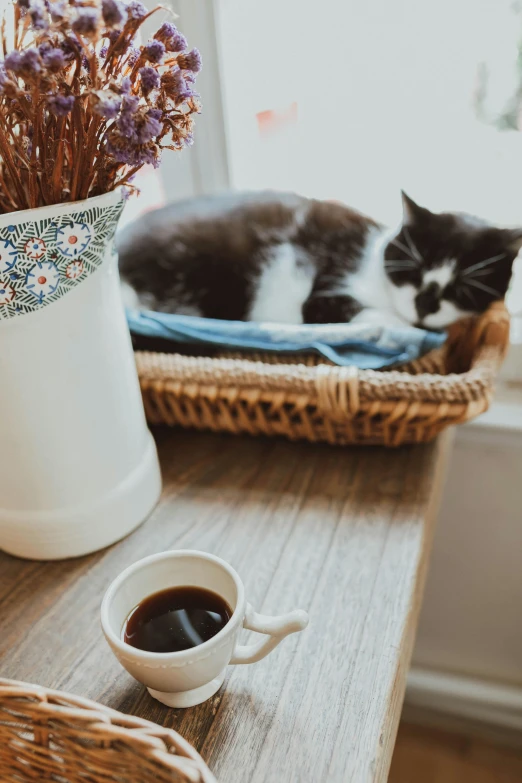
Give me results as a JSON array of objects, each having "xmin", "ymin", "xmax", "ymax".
[{"xmin": 167, "ymin": 0, "xmax": 522, "ymax": 378}]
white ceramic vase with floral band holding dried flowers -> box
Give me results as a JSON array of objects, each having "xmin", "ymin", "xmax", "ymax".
[{"xmin": 0, "ymin": 191, "xmax": 161, "ymax": 560}]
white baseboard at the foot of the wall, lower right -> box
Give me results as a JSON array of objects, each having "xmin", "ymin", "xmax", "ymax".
[{"xmin": 405, "ymin": 667, "xmax": 522, "ymax": 731}]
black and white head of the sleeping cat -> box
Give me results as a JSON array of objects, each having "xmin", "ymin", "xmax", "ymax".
[{"xmin": 384, "ymin": 194, "xmax": 522, "ymax": 329}]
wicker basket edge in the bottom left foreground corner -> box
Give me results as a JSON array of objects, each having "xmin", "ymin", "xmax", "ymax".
[{"xmin": 0, "ymin": 679, "xmax": 215, "ymax": 783}]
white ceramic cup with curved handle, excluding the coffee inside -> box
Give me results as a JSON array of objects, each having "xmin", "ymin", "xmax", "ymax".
[{"xmin": 101, "ymin": 549, "xmax": 308, "ymax": 707}]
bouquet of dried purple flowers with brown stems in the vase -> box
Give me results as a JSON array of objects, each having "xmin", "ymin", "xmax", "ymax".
[{"xmin": 0, "ymin": 0, "xmax": 201, "ymax": 213}]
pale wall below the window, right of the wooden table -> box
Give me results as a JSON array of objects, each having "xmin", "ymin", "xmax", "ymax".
[{"xmin": 413, "ymin": 404, "xmax": 522, "ymax": 685}]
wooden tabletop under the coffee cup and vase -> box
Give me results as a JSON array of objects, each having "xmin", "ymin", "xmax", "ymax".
[{"xmin": 0, "ymin": 429, "xmax": 450, "ymax": 783}]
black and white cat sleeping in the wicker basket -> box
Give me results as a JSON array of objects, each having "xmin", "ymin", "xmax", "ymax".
[{"xmin": 118, "ymin": 192, "xmax": 522, "ymax": 329}]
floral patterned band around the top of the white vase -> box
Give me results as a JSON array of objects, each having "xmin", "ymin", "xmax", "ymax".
[{"xmin": 0, "ymin": 199, "xmax": 124, "ymax": 320}]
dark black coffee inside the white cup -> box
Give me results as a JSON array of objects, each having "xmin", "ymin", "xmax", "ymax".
[{"xmin": 123, "ymin": 587, "xmax": 232, "ymax": 652}]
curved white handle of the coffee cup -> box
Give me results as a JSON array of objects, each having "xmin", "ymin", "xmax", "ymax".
[{"xmin": 230, "ymin": 604, "xmax": 308, "ymax": 663}]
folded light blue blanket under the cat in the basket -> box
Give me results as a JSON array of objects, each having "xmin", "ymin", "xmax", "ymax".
[{"xmin": 127, "ymin": 310, "xmax": 446, "ymax": 370}]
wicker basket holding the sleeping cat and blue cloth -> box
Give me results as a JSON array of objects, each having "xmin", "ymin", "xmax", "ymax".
[{"xmin": 136, "ymin": 303, "xmax": 509, "ymax": 446}]
